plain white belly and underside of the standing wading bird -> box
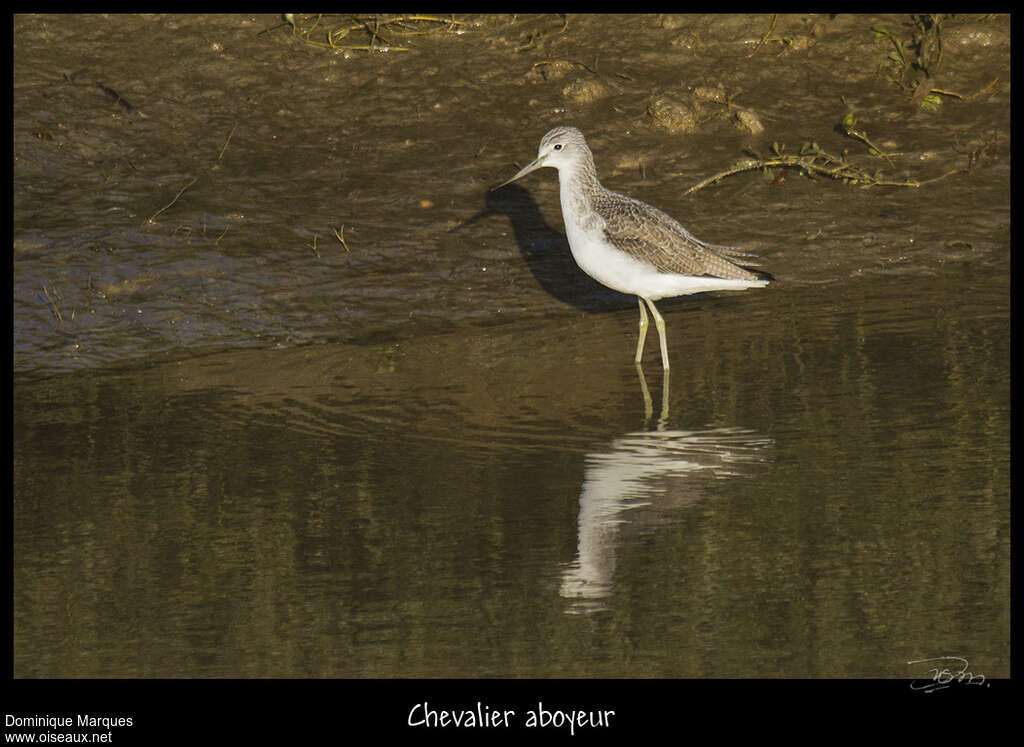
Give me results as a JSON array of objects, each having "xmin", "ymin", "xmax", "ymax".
[{"xmin": 563, "ymin": 216, "xmax": 766, "ymax": 300}]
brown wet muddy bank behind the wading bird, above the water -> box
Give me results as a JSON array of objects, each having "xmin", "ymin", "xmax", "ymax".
[{"xmin": 14, "ymin": 15, "xmax": 1010, "ymax": 373}]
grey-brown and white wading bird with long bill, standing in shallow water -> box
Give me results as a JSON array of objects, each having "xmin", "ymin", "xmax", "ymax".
[{"xmin": 494, "ymin": 127, "xmax": 772, "ymax": 371}]
